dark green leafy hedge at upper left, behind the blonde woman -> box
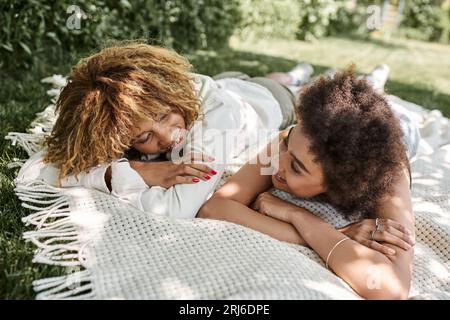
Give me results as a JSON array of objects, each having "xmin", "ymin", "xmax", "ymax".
[{"xmin": 0, "ymin": 0, "xmax": 241, "ymax": 68}]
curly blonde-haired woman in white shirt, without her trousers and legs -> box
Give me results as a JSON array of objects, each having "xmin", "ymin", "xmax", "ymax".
[{"xmin": 19, "ymin": 42, "xmax": 292, "ymax": 218}]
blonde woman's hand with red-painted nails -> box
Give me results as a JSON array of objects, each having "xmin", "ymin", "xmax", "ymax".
[{"xmin": 130, "ymin": 153, "xmax": 217, "ymax": 189}]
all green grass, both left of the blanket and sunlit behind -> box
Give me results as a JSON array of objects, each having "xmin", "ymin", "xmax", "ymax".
[{"xmin": 0, "ymin": 38, "xmax": 450, "ymax": 299}]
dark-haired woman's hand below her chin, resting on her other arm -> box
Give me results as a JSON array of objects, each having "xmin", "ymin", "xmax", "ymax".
[{"xmin": 252, "ymin": 192, "xmax": 298, "ymax": 223}]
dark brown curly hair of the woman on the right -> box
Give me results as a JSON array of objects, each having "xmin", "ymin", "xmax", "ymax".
[{"xmin": 296, "ymin": 66, "xmax": 409, "ymax": 217}]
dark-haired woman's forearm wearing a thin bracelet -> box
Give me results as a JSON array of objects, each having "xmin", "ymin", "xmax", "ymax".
[{"xmin": 291, "ymin": 208, "xmax": 409, "ymax": 299}]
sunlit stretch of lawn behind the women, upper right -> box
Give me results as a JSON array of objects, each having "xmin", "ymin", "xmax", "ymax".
[{"xmin": 227, "ymin": 38, "xmax": 450, "ymax": 117}]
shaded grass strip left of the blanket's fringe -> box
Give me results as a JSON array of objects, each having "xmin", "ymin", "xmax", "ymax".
[{"xmin": 0, "ymin": 51, "xmax": 79, "ymax": 299}]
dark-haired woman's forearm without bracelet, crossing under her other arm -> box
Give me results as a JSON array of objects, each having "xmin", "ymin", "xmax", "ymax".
[{"xmin": 197, "ymin": 197, "xmax": 307, "ymax": 246}]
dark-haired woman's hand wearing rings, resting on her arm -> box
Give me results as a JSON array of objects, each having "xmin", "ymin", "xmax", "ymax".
[{"xmin": 339, "ymin": 218, "xmax": 415, "ymax": 255}]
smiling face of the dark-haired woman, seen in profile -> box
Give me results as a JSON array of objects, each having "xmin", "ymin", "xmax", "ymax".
[{"xmin": 272, "ymin": 124, "xmax": 326, "ymax": 198}]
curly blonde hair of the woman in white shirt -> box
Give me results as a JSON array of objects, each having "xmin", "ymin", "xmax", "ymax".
[{"xmin": 44, "ymin": 42, "xmax": 200, "ymax": 185}]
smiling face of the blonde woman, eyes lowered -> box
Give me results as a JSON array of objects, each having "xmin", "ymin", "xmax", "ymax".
[{"xmin": 132, "ymin": 112, "xmax": 186, "ymax": 154}]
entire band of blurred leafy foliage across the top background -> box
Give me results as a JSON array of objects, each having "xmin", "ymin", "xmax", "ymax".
[{"xmin": 0, "ymin": 0, "xmax": 450, "ymax": 69}]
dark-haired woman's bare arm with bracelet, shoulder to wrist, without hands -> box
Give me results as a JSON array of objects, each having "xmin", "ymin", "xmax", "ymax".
[{"xmin": 289, "ymin": 166, "xmax": 414, "ymax": 299}]
